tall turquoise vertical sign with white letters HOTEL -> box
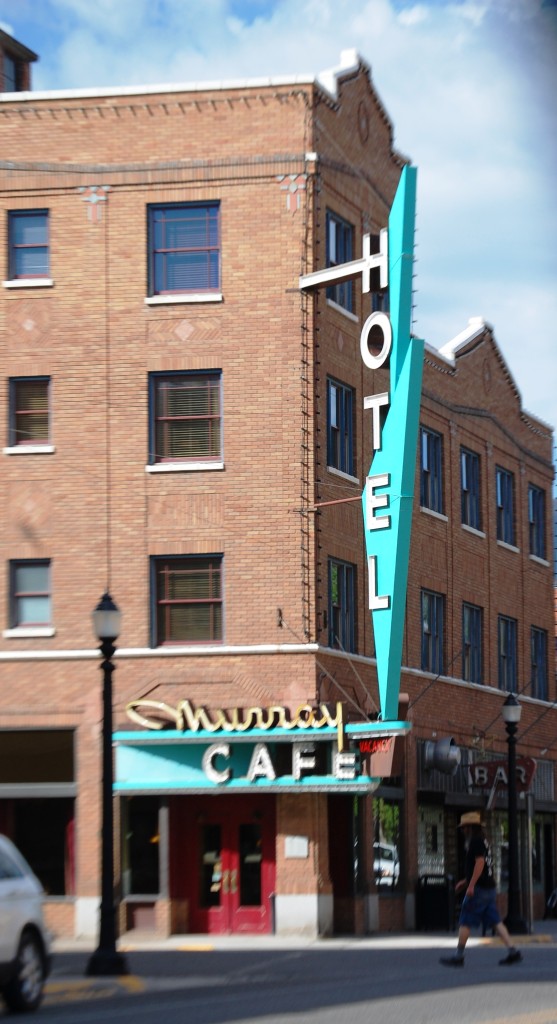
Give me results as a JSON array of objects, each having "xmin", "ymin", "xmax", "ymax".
[{"xmin": 300, "ymin": 167, "xmax": 424, "ymax": 721}]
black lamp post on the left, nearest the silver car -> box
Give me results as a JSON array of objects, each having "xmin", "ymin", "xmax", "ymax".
[{"xmin": 86, "ymin": 592, "xmax": 128, "ymax": 976}]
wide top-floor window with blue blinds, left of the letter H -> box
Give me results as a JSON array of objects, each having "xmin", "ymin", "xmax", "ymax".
[{"xmin": 148, "ymin": 203, "xmax": 220, "ymax": 295}]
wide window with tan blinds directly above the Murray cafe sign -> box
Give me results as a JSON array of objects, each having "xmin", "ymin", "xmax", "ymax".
[{"xmin": 152, "ymin": 555, "xmax": 222, "ymax": 647}]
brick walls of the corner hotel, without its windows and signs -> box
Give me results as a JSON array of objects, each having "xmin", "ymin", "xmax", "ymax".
[{"xmin": 0, "ymin": 51, "xmax": 557, "ymax": 934}]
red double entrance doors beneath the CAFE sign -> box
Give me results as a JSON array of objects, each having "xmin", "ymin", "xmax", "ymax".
[{"xmin": 172, "ymin": 795, "xmax": 274, "ymax": 934}]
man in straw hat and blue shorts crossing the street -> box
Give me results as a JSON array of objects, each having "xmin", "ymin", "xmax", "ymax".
[{"xmin": 440, "ymin": 811, "xmax": 522, "ymax": 967}]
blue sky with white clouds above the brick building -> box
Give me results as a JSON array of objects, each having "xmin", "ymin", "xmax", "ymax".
[{"xmin": 0, "ymin": 0, "xmax": 557, "ymax": 438}]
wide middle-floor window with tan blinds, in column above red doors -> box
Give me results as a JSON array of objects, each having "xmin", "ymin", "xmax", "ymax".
[{"xmin": 149, "ymin": 371, "xmax": 222, "ymax": 463}]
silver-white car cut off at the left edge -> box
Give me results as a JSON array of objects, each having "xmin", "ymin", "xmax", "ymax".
[{"xmin": 0, "ymin": 836, "xmax": 50, "ymax": 1013}]
